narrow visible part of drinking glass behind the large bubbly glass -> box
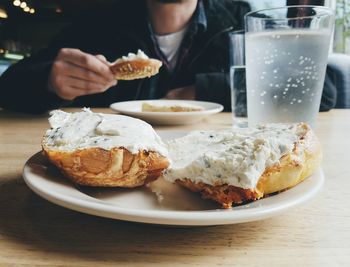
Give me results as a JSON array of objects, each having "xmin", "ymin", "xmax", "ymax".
[{"xmin": 229, "ymin": 30, "xmax": 247, "ymax": 127}]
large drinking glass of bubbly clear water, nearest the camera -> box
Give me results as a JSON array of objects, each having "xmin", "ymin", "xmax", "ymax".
[{"xmin": 245, "ymin": 6, "xmax": 334, "ymax": 126}]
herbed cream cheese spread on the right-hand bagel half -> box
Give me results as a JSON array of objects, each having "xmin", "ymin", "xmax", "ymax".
[{"xmin": 164, "ymin": 124, "xmax": 305, "ymax": 189}]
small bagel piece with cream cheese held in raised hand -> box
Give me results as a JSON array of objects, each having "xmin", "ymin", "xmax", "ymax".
[{"xmin": 110, "ymin": 50, "xmax": 162, "ymax": 80}]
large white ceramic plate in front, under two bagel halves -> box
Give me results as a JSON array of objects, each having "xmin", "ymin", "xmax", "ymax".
[{"xmin": 23, "ymin": 131, "xmax": 324, "ymax": 226}]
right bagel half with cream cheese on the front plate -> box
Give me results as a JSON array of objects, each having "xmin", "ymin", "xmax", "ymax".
[{"xmin": 164, "ymin": 123, "xmax": 322, "ymax": 208}]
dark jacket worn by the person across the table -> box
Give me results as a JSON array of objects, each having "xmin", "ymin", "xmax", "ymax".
[{"xmin": 0, "ymin": 0, "xmax": 335, "ymax": 113}]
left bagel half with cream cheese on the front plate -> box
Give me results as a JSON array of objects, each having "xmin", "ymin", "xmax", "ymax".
[{"xmin": 42, "ymin": 109, "xmax": 169, "ymax": 187}]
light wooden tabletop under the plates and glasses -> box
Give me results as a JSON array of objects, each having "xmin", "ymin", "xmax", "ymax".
[{"xmin": 0, "ymin": 109, "xmax": 350, "ymax": 267}]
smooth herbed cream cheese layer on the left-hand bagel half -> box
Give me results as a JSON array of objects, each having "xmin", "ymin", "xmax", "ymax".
[{"xmin": 44, "ymin": 109, "xmax": 167, "ymax": 156}]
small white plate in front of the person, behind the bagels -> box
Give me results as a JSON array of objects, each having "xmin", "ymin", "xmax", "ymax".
[{"xmin": 110, "ymin": 100, "xmax": 224, "ymax": 125}]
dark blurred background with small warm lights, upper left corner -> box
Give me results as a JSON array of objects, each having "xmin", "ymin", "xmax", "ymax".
[{"xmin": 0, "ymin": 0, "xmax": 113, "ymax": 75}]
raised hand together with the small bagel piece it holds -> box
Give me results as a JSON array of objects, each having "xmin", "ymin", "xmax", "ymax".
[{"xmin": 48, "ymin": 48, "xmax": 162, "ymax": 100}]
